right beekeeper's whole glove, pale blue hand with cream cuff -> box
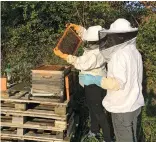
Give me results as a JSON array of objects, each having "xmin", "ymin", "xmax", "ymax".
[{"xmin": 84, "ymin": 74, "xmax": 120, "ymax": 91}]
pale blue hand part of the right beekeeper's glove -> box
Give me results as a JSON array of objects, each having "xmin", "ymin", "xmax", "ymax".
[{"xmin": 79, "ymin": 74, "xmax": 102, "ymax": 86}]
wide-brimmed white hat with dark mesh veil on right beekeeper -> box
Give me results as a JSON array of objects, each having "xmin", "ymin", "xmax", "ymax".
[{"xmin": 99, "ymin": 18, "xmax": 138, "ymax": 61}]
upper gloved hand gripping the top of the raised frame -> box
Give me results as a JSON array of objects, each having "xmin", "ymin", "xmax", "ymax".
[{"xmin": 66, "ymin": 23, "xmax": 86, "ymax": 38}]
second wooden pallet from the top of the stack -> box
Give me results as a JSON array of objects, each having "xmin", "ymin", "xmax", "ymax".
[{"xmin": 1, "ymin": 114, "xmax": 74, "ymax": 139}]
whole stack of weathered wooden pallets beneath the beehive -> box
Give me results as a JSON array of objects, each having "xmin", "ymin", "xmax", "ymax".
[{"xmin": 1, "ymin": 91, "xmax": 74, "ymax": 142}]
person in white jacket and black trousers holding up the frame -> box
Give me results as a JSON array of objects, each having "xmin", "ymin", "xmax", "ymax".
[{"xmin": 54, "ymin": 24, "xmax": 111, "ymax": 142}]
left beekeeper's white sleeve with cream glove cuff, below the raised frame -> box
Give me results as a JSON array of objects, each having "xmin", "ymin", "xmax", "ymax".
[{"xmin": 67, "ymin": 53, "xmax": 104, "ymax": 70}]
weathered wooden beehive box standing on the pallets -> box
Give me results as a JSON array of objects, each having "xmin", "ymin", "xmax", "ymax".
[{"xmin": 32, "ymin": 65, "xmax": 71, "ymax": 96}]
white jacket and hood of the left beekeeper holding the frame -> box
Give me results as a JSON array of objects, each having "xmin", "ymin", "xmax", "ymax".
[{"xmin": 67, "ymin": 26, "xmax": 106, "ymax": 86}]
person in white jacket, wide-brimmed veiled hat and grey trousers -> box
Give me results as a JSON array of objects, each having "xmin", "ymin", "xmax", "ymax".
[{"xmin": 84, "ymin": 18, "xmax": 144, "ymax": 142}]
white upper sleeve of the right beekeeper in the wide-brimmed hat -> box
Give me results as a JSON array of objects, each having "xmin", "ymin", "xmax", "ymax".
[{"xmin": 108, "ymin": 52, "xmax": 128, "ymax": 89}]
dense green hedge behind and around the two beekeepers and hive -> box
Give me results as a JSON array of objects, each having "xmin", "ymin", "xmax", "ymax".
[{"xmin": 1, "ymin": 1, "xmax": 156, "ymax": 142}]
